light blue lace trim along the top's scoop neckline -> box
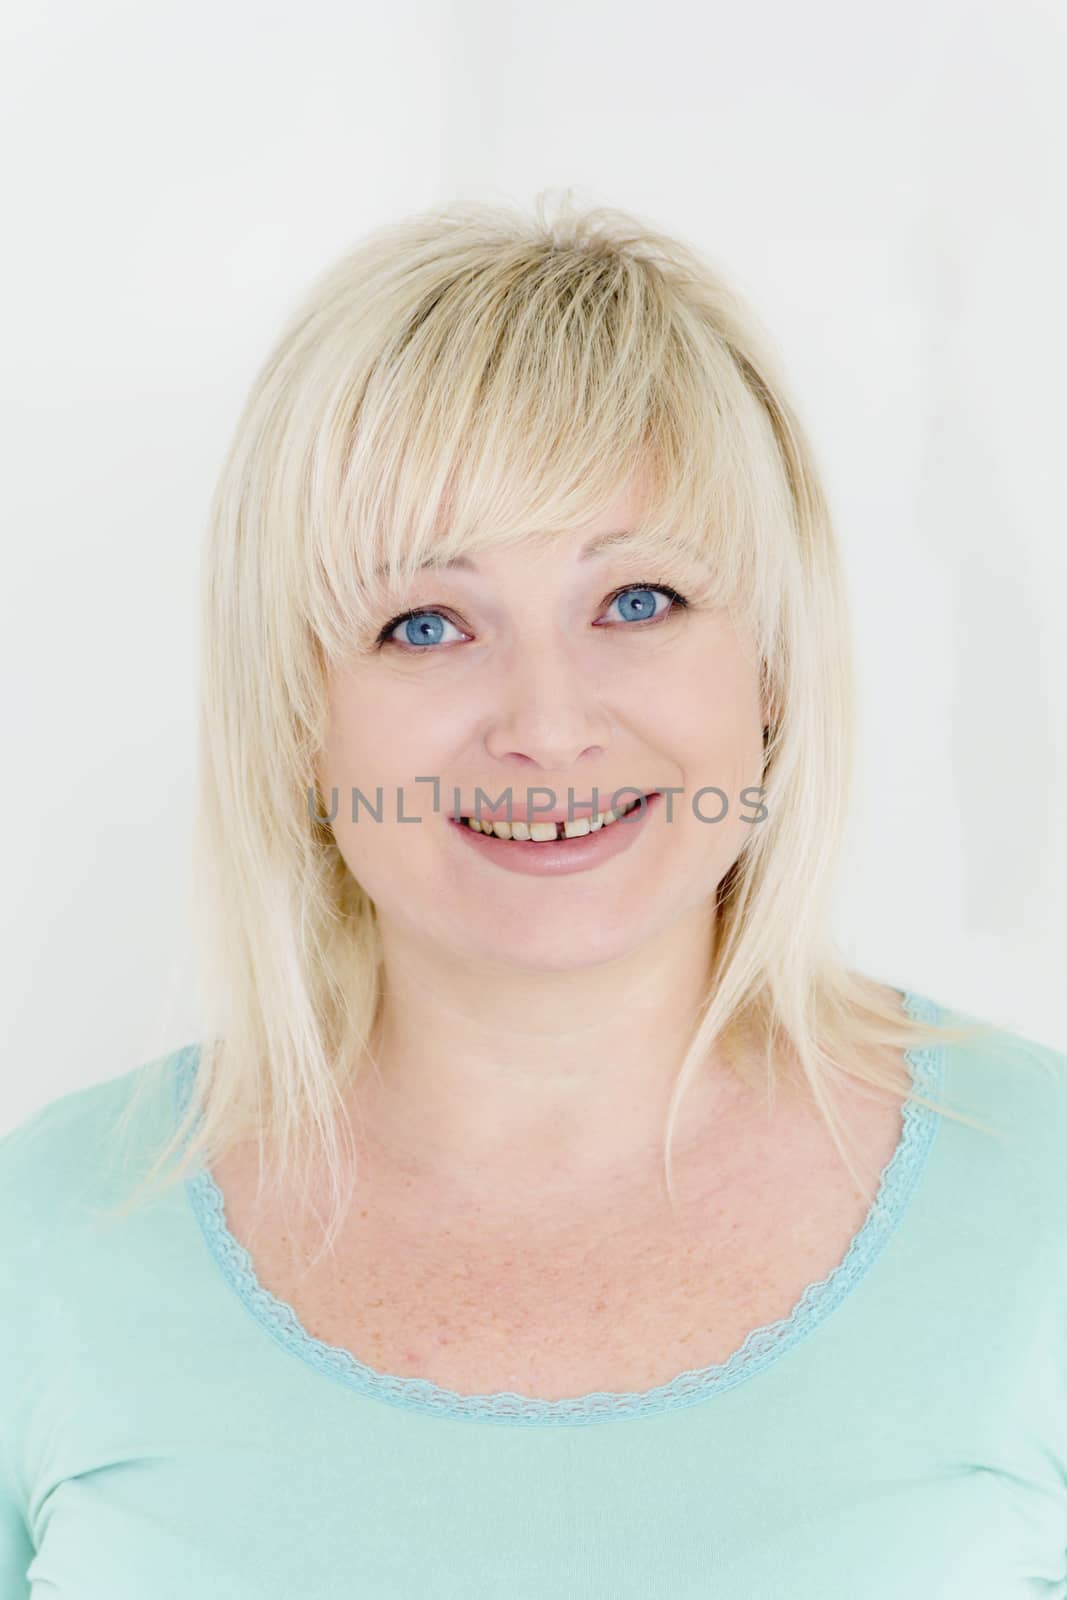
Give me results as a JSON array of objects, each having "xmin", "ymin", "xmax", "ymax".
[{"xmin": 174, "ymin": 989, "xmax": 945, "ymax": 1427}]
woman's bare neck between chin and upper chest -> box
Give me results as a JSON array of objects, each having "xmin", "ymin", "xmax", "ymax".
[{"xmin": 347, "ymin": 907, "xmax": 748, "ymax": 1197}]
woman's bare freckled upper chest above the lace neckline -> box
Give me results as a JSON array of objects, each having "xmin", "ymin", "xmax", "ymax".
[{"xmin": 206, "ymin": 1081, "xmax": 902, "ymax": 1400}]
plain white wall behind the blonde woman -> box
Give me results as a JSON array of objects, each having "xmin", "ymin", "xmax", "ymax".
[{"xmin": 0, "ymin": 0, "xmax": 1067, "ymax": 1125}]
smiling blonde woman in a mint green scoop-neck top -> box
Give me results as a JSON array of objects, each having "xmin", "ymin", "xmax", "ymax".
[{"xmin": 0, "ymin": 193, "xmax": 1067, "ymax": 1600}]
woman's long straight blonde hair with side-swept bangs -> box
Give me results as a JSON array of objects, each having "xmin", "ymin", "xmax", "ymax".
[{"xmin": 106, "ymin": 194, "xmax": 1011, "ymax": 1248}]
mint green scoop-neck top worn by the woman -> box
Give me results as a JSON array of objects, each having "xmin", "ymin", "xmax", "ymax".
[{"xmin": 0, "ymin": 994, "xmax": 1067, "ymax": 1600}]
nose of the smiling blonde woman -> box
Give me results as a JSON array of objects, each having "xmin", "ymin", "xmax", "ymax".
[{"xmin": 485, "ymin": 642, "xmax": 611, "ymax": 773}]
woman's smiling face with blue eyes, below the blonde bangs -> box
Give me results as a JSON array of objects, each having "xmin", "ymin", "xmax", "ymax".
[{"xmin": 317, "ymin": 476, "xmax": 763, "ymax": 971}]
